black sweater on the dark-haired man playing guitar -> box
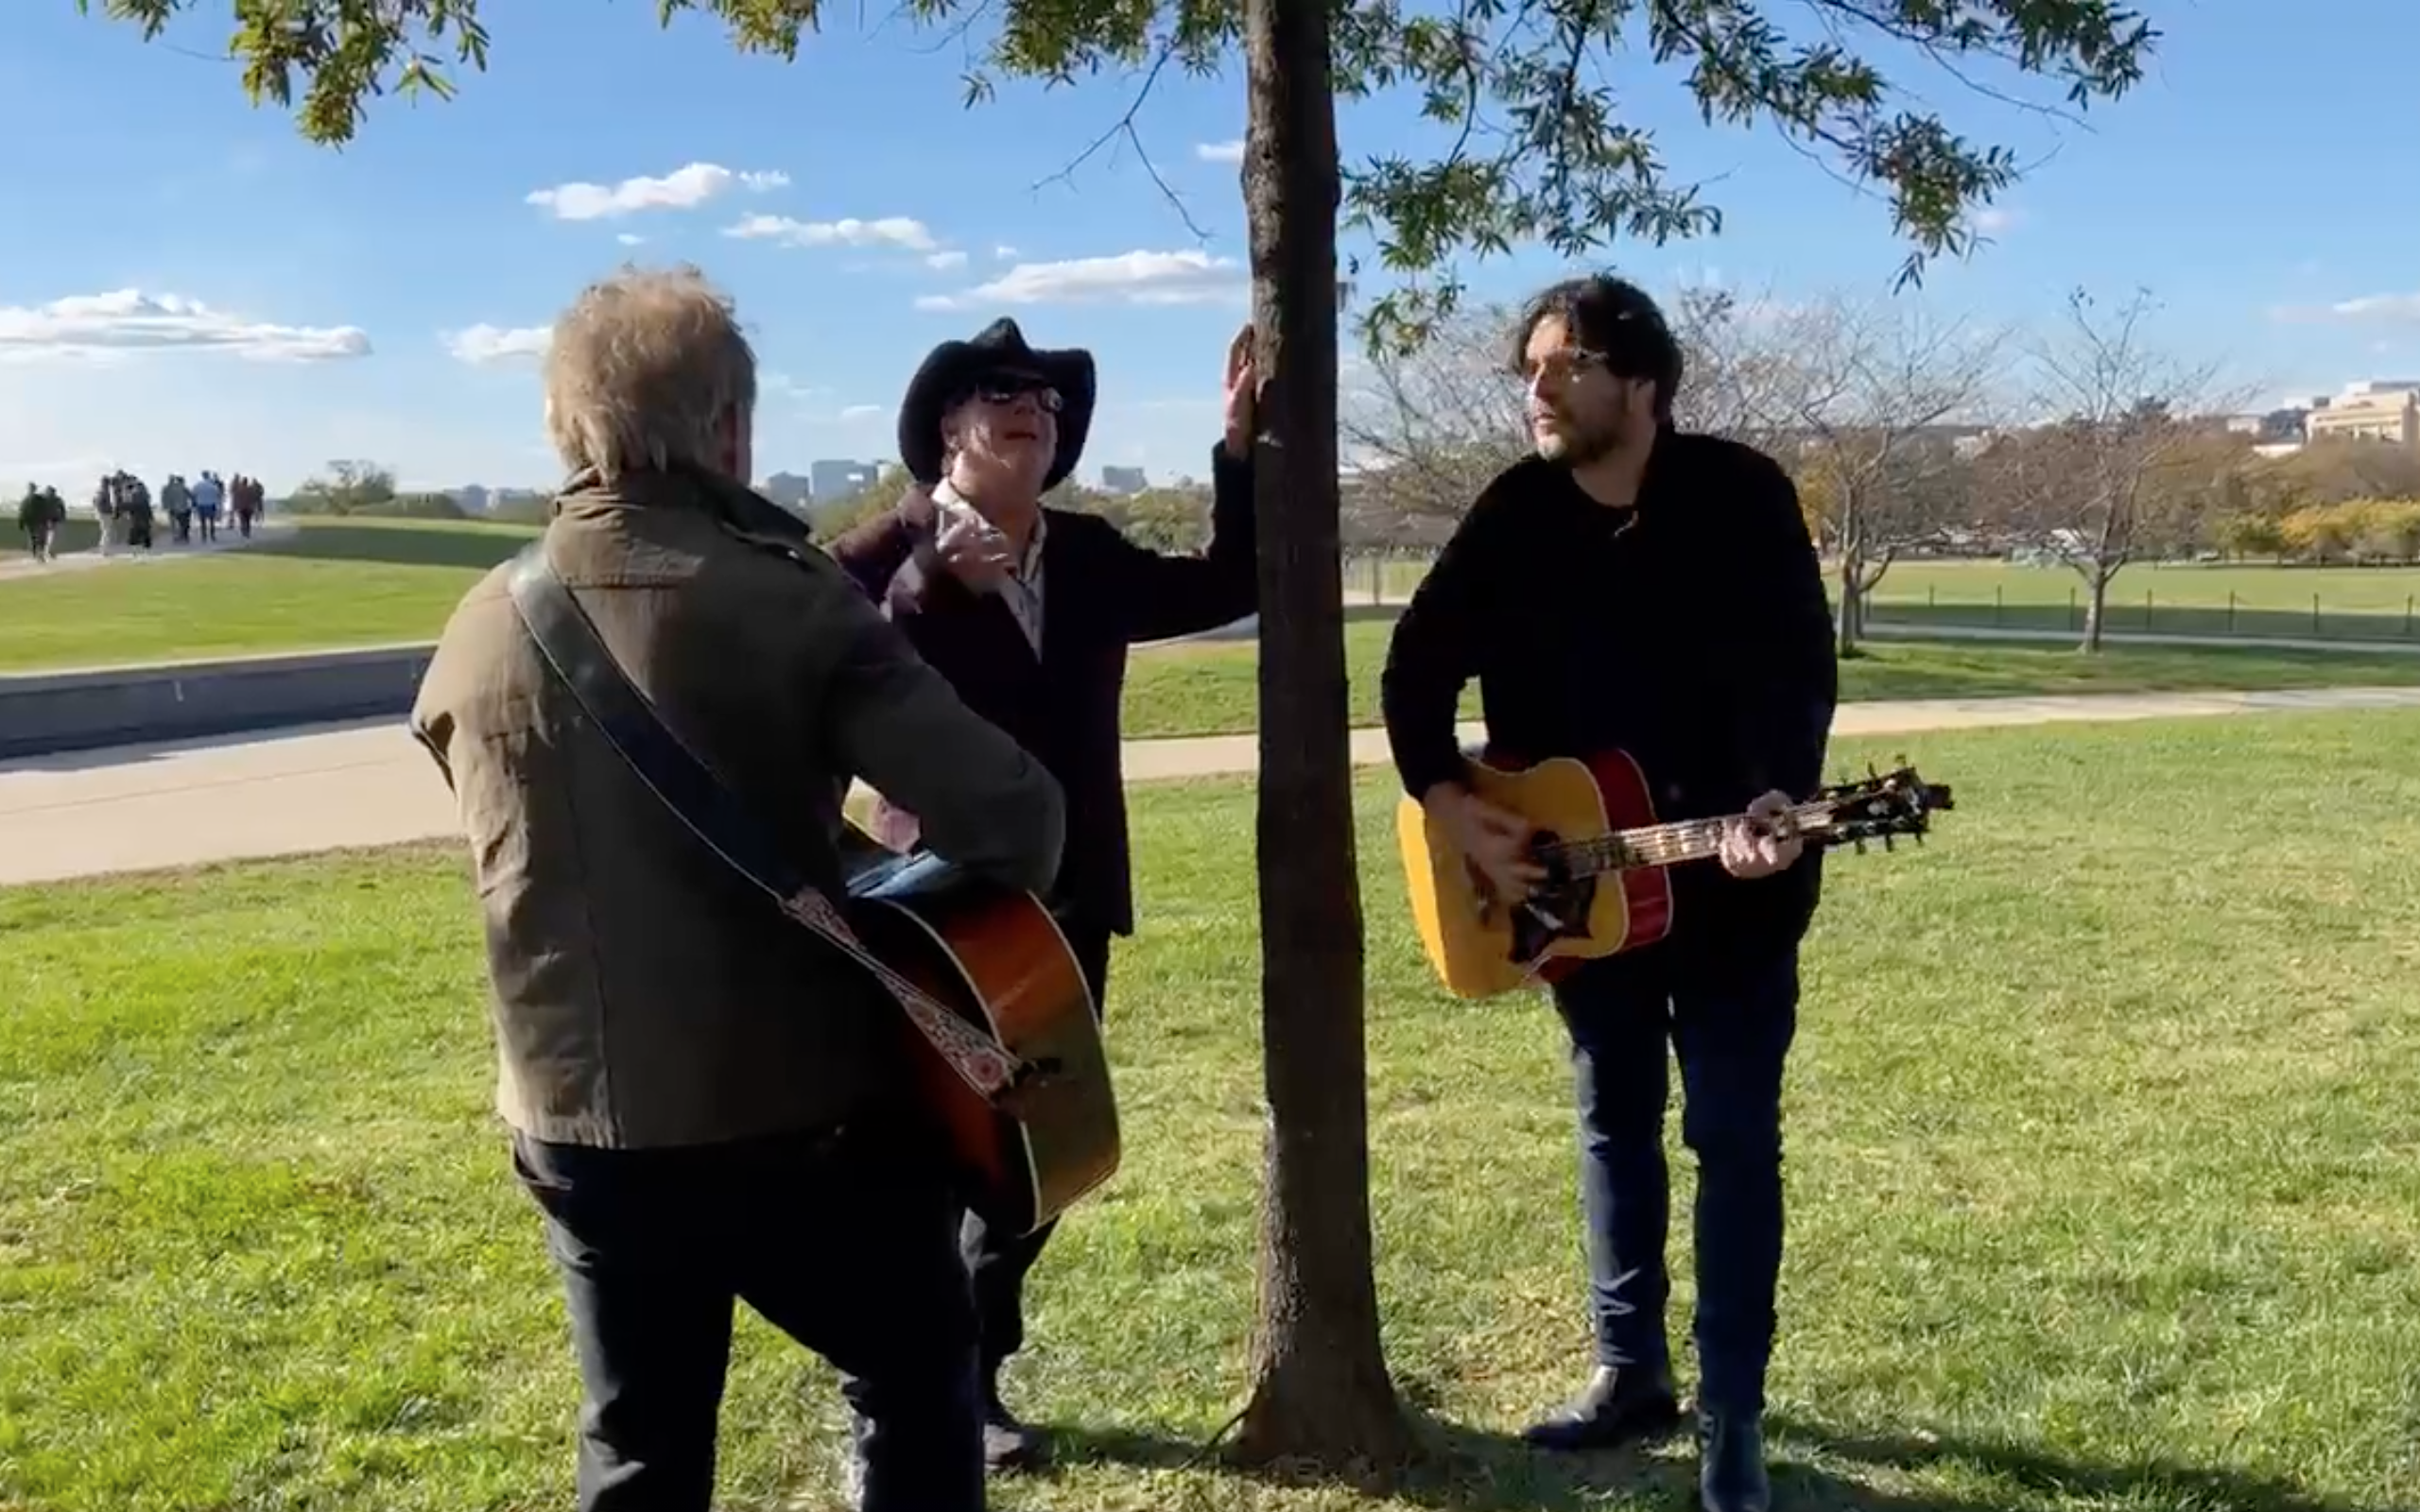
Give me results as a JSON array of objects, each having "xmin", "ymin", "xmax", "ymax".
[{"xmin": 1384, "ymin": 428, "xmax": 1840, "ymax": 943}]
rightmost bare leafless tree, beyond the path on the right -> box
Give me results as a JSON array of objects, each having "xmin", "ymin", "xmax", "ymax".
[{"xmin": 1979, "ymin": 290, "xmax": 2246, "ymax": 651}]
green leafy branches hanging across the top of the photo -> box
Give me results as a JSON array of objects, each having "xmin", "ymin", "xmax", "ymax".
[{"xmin": 78, "ymin": 0, "xmax": 2159, "ymax": 351}]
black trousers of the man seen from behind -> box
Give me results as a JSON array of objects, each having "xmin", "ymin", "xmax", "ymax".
[{"xmin": 513, "ymin": 1112, "xmax": 982, "ymax": 1512}]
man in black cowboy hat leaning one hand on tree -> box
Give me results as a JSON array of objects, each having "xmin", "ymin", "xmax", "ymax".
[{"xmin": 830, "ymin": 319, "xmax": 1258, "ymax": 1469}]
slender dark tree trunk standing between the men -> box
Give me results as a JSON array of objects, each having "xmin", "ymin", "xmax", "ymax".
[{"xmin": 1236, "ymin": 0, "xmax": 1409, "ymax": 1470}]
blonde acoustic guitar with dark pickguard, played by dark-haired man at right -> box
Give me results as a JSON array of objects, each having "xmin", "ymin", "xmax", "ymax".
[{"xmin": 1396, "ymin": 750, "xmax": 1950, "ymax": 997}]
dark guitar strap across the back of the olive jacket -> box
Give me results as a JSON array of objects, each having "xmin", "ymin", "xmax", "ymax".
[{"xmin": 509, "ymin": 537, "xmax": 1033, "ymax": 1101}]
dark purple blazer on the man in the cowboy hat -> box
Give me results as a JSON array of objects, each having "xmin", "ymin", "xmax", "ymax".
[{"xmin": 825, "ymin": 445, "xmax": 1261, "ymax": 934}]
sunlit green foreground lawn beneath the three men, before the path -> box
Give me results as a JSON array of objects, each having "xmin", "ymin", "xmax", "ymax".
[{"xmin": 0, "ymin": 713, "xmax": 2420, "ymax": 1512}]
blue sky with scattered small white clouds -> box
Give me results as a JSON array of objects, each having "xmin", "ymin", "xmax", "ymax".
[{"xmin": 0, "ymin": 0, "xmax": 2420, "ymax": 489}]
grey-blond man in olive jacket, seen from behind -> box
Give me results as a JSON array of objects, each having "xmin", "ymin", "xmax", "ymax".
[{"xmin": 411, "ymin": 271, "xmax": 1064, "ymax": 1512}]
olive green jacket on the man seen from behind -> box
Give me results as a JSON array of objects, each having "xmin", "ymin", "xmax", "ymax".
[{"xmin": 411, "ymin": 459, "xmax": 1064, "ymax": 1146}]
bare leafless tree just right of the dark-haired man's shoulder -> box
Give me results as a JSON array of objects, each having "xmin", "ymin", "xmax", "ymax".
[{"xmin": 1736, "ymin": 298, "xmax": 2004, "ymax": 658}]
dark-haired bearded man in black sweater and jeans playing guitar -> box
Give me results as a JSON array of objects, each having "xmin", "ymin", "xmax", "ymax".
[{"xmin": 1384, "ymin": 276, "xmax": 1837, "ymax": 1512}]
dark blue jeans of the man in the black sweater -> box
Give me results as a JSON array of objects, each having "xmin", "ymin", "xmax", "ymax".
[{"xmin": 1556, "ymin": 946, "xmax": 1798, "ymax": 1413}]
